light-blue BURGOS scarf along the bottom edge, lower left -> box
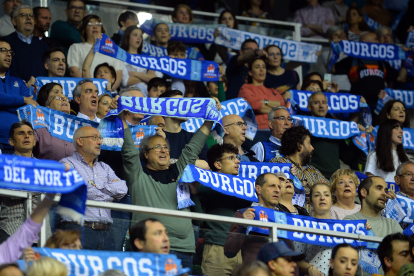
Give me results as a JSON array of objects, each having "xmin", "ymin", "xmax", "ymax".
[{"xmin": 33, "ymin": 247, "xmax": 189, "ymax": 276}]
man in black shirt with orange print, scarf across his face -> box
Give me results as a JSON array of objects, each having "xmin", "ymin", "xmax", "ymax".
[{"xmin": 332, "ymin": 32, "xmax": 407, "ymax": 125}]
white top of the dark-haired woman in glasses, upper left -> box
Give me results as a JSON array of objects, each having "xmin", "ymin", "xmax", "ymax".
[{"xmin": 68, "ymin": 42, "xmax": 123, "ymax": 78}]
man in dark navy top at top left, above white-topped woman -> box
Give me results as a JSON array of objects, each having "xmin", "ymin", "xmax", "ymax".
[{"xmin": 50, "ymin": 0, "xmax": 86, "ymax": 56}]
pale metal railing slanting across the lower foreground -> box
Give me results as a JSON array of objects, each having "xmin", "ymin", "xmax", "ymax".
[{"xmin": 0, "ymin": 189, "xmax": 382, "ymax": 246}]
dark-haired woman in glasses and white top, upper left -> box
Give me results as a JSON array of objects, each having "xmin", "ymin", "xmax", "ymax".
[{"xmin": 68, "ymin": 14, "xmax": 123, "ymax": 91}]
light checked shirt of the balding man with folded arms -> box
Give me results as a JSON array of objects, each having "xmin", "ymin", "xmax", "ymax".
[{"xmin": 60, "ymin": 152, "xmax": 128, "ymax": 223}]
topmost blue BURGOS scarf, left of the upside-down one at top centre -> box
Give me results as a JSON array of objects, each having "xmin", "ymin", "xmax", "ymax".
[{"xmin": 141, "ymin": 19, "xmax": 220, "ymax": 43}]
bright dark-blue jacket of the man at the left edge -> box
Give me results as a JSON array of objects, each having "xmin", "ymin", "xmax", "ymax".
[{"xmin": 0, "ymin": 71, "xmax": 30, "ymax": 144}]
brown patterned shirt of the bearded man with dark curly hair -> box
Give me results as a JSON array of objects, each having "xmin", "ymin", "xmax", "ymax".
[{"xmin": 269, "ymin": 156, "xmax": 329, "ymax": 214}]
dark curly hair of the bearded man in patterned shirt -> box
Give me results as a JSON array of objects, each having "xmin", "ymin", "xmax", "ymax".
[{"xmin": 279, "ymin": 126, "xmax": 312, "ymax": 156}]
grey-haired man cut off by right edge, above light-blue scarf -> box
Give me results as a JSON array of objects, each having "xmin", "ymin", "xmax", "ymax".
[{"xmin": 394, "ymin": 161, "xmax": 414, "ymax": 229}]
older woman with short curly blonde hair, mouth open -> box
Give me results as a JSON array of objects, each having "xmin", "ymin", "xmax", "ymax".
[{"xmin": 330, "ymin": 169, "xmax": 361, "ymax": 219}]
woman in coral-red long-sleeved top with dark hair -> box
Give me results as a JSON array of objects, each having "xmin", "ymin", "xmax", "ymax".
[{"xmin": 239, "ymin": 58, "xmax": 290, "ymax": 135}]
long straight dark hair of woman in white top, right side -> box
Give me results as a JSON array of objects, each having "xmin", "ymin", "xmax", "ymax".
[{"xmin": 375, "ymin": 119, "xmax": 408, "ymax": 172}]
